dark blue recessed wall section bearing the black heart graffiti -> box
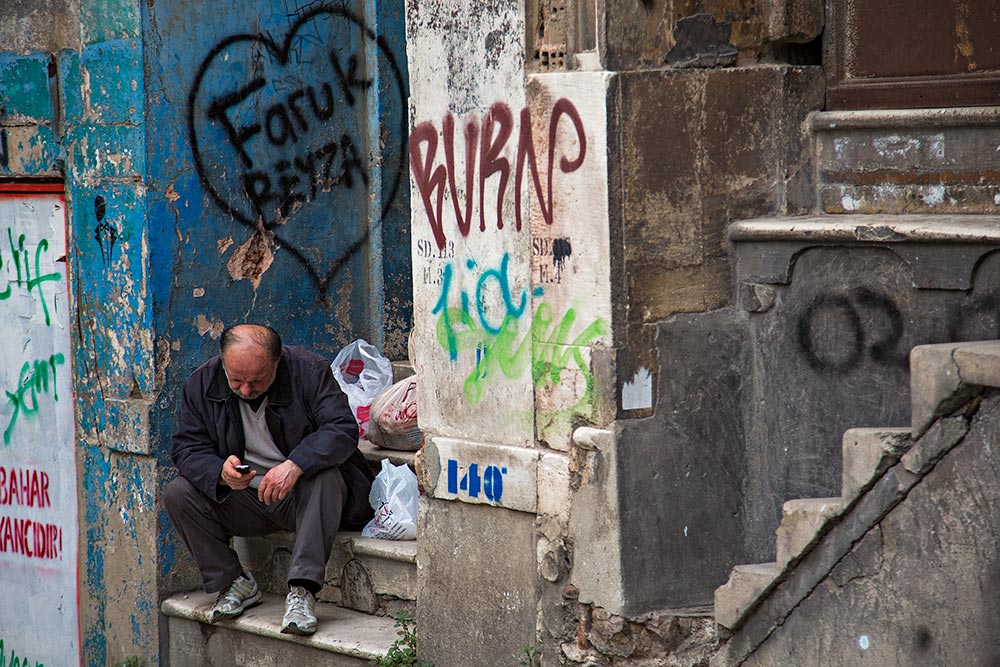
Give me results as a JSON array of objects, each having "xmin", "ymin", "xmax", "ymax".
[{"xmin": 143, "ymin": 0, "xmax": 412, "ymax": 632}]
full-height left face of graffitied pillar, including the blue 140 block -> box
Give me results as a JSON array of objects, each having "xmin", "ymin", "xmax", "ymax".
[{"xmin": 406, "ymin": 2, "xmax": 535, "ymax": 665}]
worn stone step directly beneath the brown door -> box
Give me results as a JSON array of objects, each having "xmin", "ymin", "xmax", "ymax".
[{"xmin": 808, "ymin": 107, "xmax": 1000, "ymax": 213}]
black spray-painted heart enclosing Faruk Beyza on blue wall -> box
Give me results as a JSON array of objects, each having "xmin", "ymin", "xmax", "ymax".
[{"xmin": 188, "ymin": 7, "xmax": 406, "ymax": 294}]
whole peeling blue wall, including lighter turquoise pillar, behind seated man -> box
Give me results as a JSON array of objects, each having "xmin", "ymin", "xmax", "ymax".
[{"xmin": 0, "ymin": 0, "xmax": 412, "ymax": 665}]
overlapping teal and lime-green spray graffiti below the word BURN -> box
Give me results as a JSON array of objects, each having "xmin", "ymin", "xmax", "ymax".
[{"xmin": 432, "ymin": 254, "xmax": 608, "ymax": 407}]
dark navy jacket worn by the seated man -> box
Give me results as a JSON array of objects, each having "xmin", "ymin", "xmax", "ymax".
[{"xmin": 173, "ymin": 346, "xmax": 374, "ymax": 529}]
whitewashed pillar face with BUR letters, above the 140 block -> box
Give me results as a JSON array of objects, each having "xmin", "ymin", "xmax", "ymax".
[{"xmin": 407, "ymin": 2, "xmax": 533, "ymax": 445}]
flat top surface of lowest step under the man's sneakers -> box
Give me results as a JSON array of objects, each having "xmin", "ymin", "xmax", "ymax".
[{"xmin": 161, "ymin": 593, "xmax": 398, "ymax": 660}]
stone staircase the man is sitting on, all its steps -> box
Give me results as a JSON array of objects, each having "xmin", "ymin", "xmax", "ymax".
[{"xmin": 161, "ymin": 363, "xmax": 417, "ymax": 667}]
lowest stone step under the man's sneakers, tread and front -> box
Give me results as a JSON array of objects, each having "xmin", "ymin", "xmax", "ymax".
[{"xmin": 161, "ymin": 593, "xmax": 397, "ymax": 667}]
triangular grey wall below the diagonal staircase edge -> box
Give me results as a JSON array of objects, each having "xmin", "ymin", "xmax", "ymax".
[{"xmin": 742, "ymin": 393, "xmax": 1000, "ymax": 667}]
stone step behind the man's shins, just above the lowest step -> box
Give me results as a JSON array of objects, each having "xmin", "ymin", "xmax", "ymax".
[{"xmin": 234, "ymin": 532, "xmax": 417, "ymax": 616}]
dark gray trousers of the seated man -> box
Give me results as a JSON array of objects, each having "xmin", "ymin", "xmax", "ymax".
[{"xmin": 163, "ymin": 468, "xmax": 347, "ymax": 593}]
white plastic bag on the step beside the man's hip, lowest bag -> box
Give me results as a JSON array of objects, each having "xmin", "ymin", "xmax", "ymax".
[{"xmin": 361, "ymin": 459, "xmax": 420, "ymax": 540}]
